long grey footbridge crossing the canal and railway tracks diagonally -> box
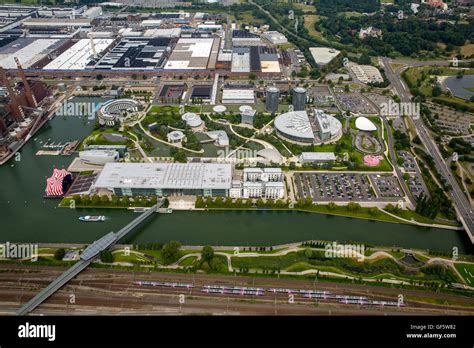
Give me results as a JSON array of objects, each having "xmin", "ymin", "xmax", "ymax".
[{"xmin": 16, "ymin": 201, "xmax": 163, "ymax": 315}]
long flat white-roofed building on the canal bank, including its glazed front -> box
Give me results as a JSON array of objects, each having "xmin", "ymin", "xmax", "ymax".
[{"xmin": 94, "ymin": 163, "xmax": 232, "ymax": 197}]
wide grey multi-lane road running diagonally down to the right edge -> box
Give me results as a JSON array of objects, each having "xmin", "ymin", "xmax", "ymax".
[{"xmin": 380, "ymin": 57, "xmax": 474, "ymax": 243}]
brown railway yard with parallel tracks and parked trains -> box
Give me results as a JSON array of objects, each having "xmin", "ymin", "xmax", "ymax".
[{"xmin": 0, "ymin": 266, "xmax": 474, "ymax": 315}]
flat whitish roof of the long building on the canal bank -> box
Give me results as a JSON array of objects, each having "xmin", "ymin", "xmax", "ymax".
[{"xmin": 94, "ymin": 163, "xmax": 232, "ymax": 189}]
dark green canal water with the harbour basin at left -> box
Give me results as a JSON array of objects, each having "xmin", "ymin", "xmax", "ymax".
[{"xmin": 0, "ymin": 96, "xmax": 472, "ymax": 253}]
